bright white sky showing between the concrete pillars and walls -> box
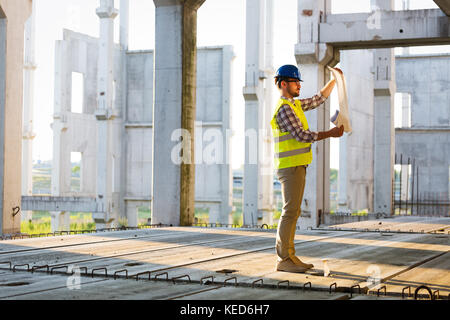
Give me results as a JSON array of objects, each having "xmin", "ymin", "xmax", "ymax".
[{"xmin": 29, "ymin": 0, "xmax": 449, "ymax": 168}]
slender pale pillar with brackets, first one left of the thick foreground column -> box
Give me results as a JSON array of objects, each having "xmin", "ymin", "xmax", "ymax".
[{"xmin": 93, "ymin": 0, "xmax": 118, "ymax": 229}]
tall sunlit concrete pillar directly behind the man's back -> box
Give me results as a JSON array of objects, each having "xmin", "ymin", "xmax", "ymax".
[{"xmin": 243, "ymin": 0, "xmax": 274, "ymax": 225}]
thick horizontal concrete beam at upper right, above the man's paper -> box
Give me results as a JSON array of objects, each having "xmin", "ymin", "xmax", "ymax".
[{"xmin": 318, "ymin": 9, "xmax": 450, "ymax": 49}]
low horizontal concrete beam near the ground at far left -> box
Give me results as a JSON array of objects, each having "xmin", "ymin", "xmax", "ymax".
[{"xmin": 22, "ymin": 196, "xmax": 100, "ymax": 212}]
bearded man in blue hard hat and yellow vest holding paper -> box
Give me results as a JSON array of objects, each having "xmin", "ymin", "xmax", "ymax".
[{"xmin": 270, "ymin": 65, "xmax": 344, "ymax": 272}]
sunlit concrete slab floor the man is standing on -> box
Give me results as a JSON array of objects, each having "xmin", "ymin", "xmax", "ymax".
[{"xmin": 0, "ymin": 217, "xmax": 450, "ymax": 300}]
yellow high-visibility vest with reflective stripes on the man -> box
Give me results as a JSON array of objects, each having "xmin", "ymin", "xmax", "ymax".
[{"xmin": 270, "ymin": 98, "xmax": 312, "ymax": 169}]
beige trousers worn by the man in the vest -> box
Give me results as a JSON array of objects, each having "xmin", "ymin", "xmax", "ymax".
[{"xmin": 276, "ymin": 166, "xmax": 306, "ymax": 261}]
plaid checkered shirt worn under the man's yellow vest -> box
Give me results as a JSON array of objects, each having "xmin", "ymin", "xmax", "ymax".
[{"xmin": 276, "ymin": 93, "xmax": 327, "ymax": 143}]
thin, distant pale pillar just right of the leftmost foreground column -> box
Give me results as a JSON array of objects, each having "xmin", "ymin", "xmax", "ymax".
[{"xmin": 21, "ymin": 1, "xmax": 36, "ymax": 221}]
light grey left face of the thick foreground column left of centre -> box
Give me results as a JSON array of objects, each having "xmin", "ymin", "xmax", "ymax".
[{"xmin": 152, "ymin": 1, "xmax": 183, "ymax": 225}]
